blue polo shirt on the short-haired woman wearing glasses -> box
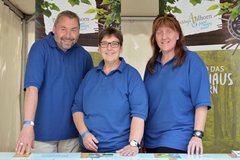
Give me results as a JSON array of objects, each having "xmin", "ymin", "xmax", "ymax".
[{"xmin": 72, "ymin": 58, "xmax": 148, "ymax": 152}]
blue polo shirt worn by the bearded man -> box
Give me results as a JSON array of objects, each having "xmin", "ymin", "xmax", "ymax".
[{"xmin": 24, "ymin": 32, "xmax": 93, "ymax": 141}]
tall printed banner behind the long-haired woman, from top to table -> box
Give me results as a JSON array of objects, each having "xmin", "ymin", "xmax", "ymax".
[{"xmin": 171, "ymin": 0, "xmax": 240, "ymax": 153}]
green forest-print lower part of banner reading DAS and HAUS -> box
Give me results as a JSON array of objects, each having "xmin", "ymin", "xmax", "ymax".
[{"xmin": 198, "ymin": 50, "xmax": 240, "ymax": 153}]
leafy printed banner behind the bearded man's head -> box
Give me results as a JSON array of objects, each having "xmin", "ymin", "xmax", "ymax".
[{"xmin": 35, "ymin": 0, "xmax": 121, "ymax": 52}]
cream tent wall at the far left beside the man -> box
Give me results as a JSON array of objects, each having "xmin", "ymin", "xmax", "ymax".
[{"xmin": 0, "ymin": 0, "xmax": 35, "ymax": 152}]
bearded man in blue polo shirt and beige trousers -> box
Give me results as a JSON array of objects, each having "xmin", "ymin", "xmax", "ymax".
[{"xmin": 16, "ymin": 11, "xmax": 93, "ymax": 154}]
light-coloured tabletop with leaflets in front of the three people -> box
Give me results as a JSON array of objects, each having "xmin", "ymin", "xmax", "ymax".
[{"xmin": 0, "ymin": 152, "xmax": 237, "ymax": 160}]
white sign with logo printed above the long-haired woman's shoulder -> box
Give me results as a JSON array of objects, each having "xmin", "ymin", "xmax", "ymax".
[{"xmin": 169, "ymin": 0, "xmax": 222, "ymax": 36}]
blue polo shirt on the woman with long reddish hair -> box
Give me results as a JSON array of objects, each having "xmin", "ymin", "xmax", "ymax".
[{"xmin": 144, "ymin": 50, "xmax": 211, "ymax": 151}]
